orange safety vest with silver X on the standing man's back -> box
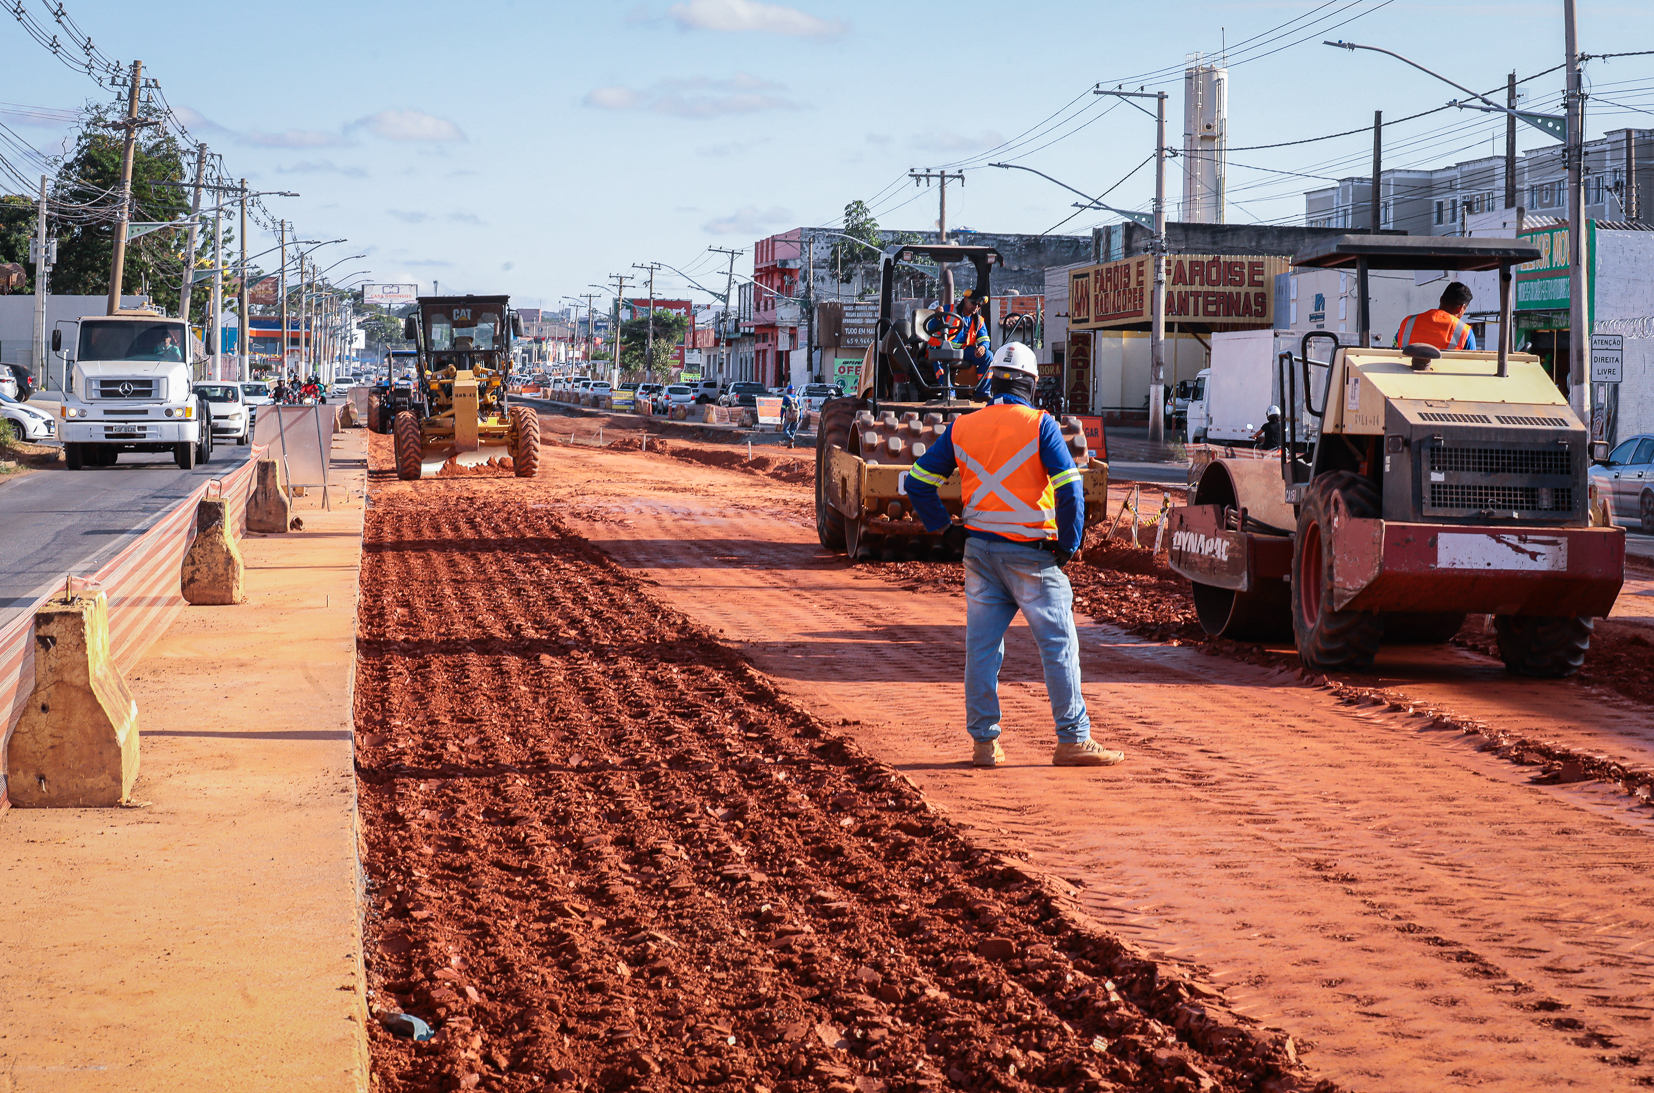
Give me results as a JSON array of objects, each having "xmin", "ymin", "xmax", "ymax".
[{"xmin": 953, "ymin": 402, "xmax": 1058, "ymax": 542}]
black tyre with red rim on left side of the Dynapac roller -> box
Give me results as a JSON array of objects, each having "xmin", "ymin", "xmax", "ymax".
[{"xmin": 1292, "ymin": 471, "xmax": 1384, "ymax": 671}]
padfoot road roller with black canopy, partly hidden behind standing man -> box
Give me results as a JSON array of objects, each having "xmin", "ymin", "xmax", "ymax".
[{"xmin": 815, "ymin": 243, "xmax": 1108, "ymax": 562}]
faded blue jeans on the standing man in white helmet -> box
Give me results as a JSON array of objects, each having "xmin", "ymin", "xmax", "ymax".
[{"xmin": 964, "ymin": 537, "xmax": 1092, "ymax": 744}]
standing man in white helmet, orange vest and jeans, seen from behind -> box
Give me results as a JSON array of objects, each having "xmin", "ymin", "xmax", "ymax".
[{"xmin": 906, "ymin": 342, "xmax": 1125, "ymax": 767}]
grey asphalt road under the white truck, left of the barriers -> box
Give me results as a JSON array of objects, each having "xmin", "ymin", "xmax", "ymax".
[{"xmin": 0, "ymin": 445, "xmax": 250, "ymax": 622}]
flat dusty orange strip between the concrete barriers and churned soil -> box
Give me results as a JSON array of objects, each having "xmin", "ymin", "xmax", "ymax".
[{"xmin": 0, "ymin": 430, "xmax": 369, "ymax": 1093}]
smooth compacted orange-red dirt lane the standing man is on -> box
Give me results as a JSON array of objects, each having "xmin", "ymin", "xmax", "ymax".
[{"xmin": 502, "ymin": 429, "xmax": 1654, "ymax": 1090}]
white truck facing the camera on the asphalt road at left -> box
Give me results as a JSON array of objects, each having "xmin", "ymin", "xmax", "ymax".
[{"xmin": 51, "ymin": 311, "xmax": 212, "ymax": 471}]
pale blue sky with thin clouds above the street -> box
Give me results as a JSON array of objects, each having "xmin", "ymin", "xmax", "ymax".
[{"xmin": 0, "ymin": 0, "xmax": 1654, "ymax": 306}]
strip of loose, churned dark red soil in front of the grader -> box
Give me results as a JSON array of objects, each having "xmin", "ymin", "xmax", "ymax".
[{"xmin": 356, "ymin": 484, "xmax": 1302, "ymax": 1093}]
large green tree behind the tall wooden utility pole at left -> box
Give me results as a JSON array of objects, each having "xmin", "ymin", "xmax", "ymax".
[{"xmin": 51, "ymin": 104, "xmax": 189, "ymax": 316}]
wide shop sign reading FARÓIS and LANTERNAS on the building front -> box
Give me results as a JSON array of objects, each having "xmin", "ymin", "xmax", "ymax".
[{"xmin": 1068, "ymin": 255, "xmax": 1290, "ymax": 331}]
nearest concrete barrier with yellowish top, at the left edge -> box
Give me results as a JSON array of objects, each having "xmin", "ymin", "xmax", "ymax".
[{"xmin": 7, "ymin": 592, "xmax": 137, "ymax": 809}]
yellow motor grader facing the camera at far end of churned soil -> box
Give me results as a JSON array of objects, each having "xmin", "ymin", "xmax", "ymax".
[{"xmin": 377, "ymin": 296, "xmax": 539, "ymax": 480}]
